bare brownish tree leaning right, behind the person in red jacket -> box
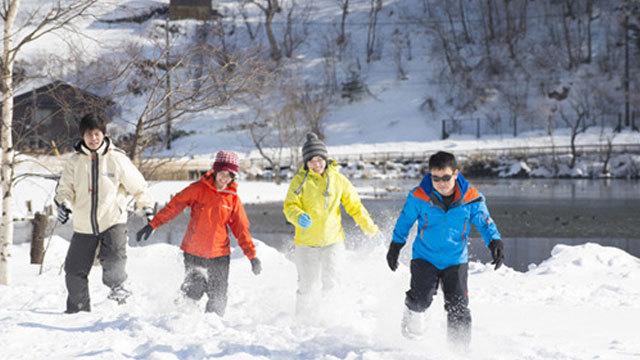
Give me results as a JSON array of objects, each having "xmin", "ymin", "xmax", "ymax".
[{"xmin": 116, "ymin": 35, "xmax": 264, "ymax": 160}]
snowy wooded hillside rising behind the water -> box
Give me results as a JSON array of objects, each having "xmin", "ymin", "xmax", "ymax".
[{"xmin": 7, "ymin": 0, "xmax": 640, "ymax": 162}]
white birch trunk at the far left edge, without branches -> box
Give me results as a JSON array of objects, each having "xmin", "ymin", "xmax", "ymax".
[{"xmin": 0, "ymin": 0, "xmax": 20, "ymax": 285}]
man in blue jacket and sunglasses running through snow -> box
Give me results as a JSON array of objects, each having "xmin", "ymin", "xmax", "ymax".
[{"xmin": 387, "ymin": 151, "xmax": 504, "ymax": 346}]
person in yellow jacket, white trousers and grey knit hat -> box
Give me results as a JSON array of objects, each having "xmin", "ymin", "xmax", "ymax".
[{"xmin": 283, "ymin": 133, "xmax": 383, "ymax": 316}]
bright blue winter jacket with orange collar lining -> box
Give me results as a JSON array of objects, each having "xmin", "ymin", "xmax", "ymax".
[{"xmin": 393, "ymin": 174, "xmax": 501, "ymax": 270}]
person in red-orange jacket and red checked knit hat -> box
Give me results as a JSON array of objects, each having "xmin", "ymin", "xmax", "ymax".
[{"xmin": 136, "ymin": 150, "xmax": 262, "ymax": 316}]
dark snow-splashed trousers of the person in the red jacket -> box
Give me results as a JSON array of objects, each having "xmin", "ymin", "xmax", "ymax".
[{"xmin": 180, "ymin": 253, "xmax": 230, "ymax": 316}]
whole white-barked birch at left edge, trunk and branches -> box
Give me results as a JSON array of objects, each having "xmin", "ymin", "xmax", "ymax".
[{"xmin": 0, "ymin": 0, "xmax": 97, "ymax": 285}]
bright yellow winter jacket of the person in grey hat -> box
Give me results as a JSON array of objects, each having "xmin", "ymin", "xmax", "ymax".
[{"xmin": 283, "ymin": 159, "xmax": 379, "ymax": 247}]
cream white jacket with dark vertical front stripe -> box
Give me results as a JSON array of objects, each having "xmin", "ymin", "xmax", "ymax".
[{"xmin": 55, "ymin": 137, "xmax": 153, "ymax": 235}]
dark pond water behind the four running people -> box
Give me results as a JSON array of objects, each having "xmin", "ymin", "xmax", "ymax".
[{"xmin": 16, "ymin": 179, "xmax": 640, "ymax": 271}]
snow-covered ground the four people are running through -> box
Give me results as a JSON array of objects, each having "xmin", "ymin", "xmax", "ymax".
[{"xmin": 0, "ymin": 237, "xmax": 640, "ymax": 360}]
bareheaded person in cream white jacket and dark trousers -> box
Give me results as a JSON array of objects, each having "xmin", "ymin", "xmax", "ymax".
[{"xmin": 54, "ymin": 114, "xmax": 153, "ymax": 313}]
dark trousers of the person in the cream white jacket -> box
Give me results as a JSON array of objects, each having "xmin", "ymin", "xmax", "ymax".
[{"xmin": 64, "ymin": 224, "xmax": 127, "ymax": 312}]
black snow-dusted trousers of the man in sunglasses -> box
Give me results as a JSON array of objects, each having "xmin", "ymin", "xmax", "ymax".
[{"xmin": 405, "ymin": 259, "xmax": 471, "ymax": 337}]
